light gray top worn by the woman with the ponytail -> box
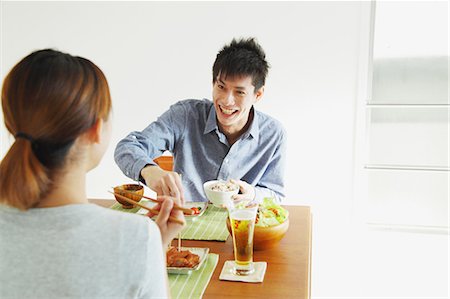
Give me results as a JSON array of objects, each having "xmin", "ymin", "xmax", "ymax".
[{"xmin": 0, "ymin": 204, "xmax": 167, "ymax": 298}]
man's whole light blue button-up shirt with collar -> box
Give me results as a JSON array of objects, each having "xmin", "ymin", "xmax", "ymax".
[{"xmin": 114, "ymin": 99, "xmax": 286, "ymax": 201}]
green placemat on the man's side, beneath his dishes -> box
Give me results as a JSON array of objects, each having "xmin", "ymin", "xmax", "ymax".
[{"xmin": 110, "ymin": 200, "xmax": 230, "ymax": 241}]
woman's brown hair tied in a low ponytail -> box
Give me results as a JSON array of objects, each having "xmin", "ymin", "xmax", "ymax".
[{"xmin": 0, "ymin": 49, "xmax": 111, "ymax": 210}]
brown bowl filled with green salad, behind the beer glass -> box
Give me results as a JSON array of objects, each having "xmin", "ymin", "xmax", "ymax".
[{"xmin": 227, "ymin": 198, "xmax": 289, "ymax": 250}]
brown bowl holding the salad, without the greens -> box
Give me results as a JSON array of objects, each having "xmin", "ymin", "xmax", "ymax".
[{"xmin": 227, "ymin": 218, "xmax": 289, "ymax": 250}]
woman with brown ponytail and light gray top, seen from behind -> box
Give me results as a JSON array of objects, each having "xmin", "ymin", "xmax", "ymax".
[{"xmin": 0, "ymin": 50, "xmax": 184, "ymax": 298}]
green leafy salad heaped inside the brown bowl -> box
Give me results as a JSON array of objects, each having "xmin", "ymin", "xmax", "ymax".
[{"xmin": 256, "ymin": 198, "xmax": 289, "ymax": 227}]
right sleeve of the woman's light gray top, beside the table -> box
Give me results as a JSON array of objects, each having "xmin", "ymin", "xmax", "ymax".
[{"xmin": 139, "ymin": 219, "xmax": 169, "ymax": 298}]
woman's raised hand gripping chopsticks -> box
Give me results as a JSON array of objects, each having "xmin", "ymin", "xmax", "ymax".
[{"xmin": 147, "ymin": 196, "xmax": 186, "ymax": 248}]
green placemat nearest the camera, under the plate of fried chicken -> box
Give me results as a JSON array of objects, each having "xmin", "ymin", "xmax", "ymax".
[{"xmin": 169, "ymin": 253, "xmax": 219, "ymax": 299}]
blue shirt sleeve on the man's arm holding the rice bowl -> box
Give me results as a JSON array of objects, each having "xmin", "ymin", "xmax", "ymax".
[{"xmin": 255, "ymin": 129, "xmax": 287, "ymax": 202}]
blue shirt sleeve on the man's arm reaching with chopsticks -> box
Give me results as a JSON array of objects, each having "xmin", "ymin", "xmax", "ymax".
[{"xmin": 114, "ymin": 102, "xmax": 187, "ymax": 181}]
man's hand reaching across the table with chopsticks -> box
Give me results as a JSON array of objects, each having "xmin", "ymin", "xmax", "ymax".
[{"xmin": 141, "ymin": 165, "xmax": 185, "ymax": 205}]
